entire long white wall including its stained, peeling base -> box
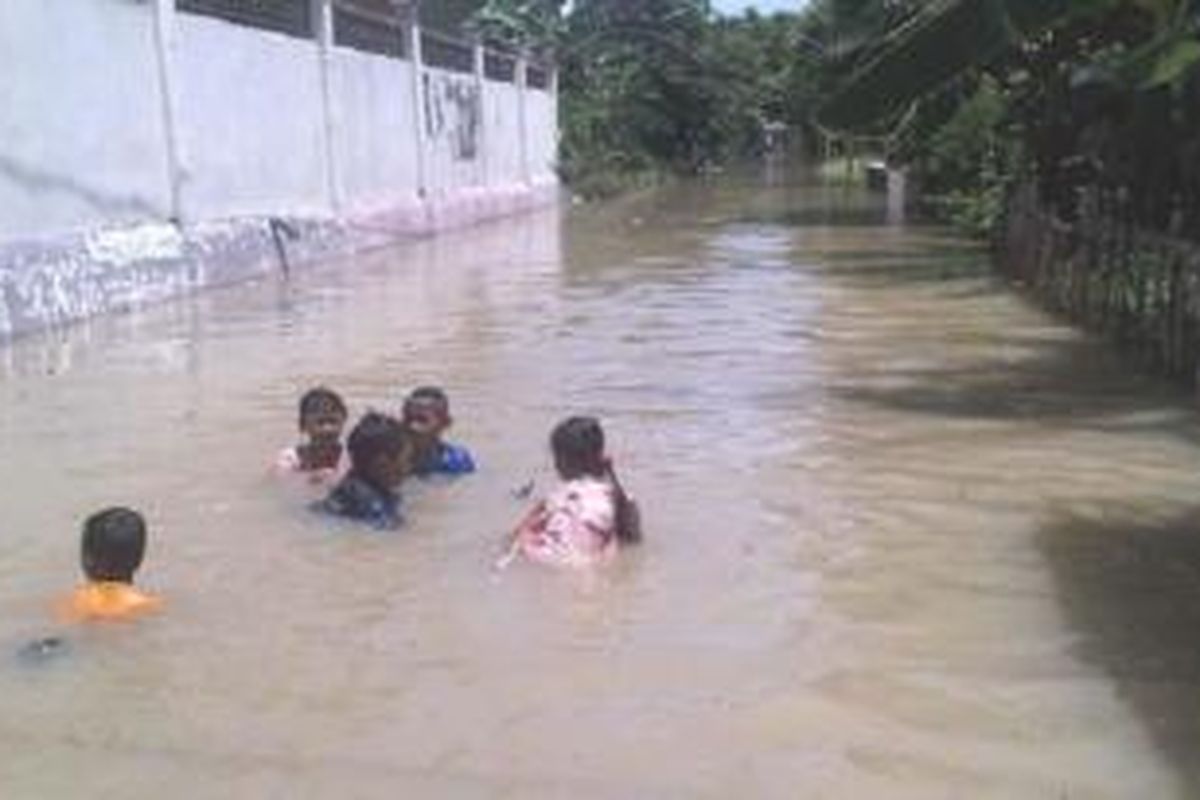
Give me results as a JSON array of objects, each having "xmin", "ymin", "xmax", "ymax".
[{"xmin": 0, "ymin": 0, "xmax": 557, "ymax": 339}]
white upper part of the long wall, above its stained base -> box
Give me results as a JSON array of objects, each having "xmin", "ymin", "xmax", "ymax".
[{"xmin": 0, "ymin": 0, "xmax": 557, "ymax": 251}]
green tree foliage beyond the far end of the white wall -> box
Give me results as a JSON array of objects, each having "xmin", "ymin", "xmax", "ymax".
[{"xmin": 451, "ymin": 0, "xmax": 816, "ymax": 193}]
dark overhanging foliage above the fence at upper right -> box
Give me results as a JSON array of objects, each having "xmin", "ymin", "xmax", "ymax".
[{"xmin": 818, "ymin": 0, "xmax": 1200, "ymax": 233}]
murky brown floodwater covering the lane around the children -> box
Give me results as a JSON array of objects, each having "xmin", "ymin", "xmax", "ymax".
[{"xmin": 0, "ymin": 175, "xmax": 1200, "ymax": 800}]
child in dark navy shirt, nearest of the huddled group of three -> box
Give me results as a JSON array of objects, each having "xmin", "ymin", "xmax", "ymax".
[{"xmin": 317, "ymin": 411, "xmax": 414, "ymax": 530}]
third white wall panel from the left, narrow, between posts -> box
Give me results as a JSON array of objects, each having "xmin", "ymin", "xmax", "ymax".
[{"xmin": 330, "ymin": 47, "xmax": 419, "ymax": 215}]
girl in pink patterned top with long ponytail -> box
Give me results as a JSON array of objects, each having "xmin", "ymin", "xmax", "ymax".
[{"xmin": 498, "ymin": 416, "xmax": 642, "ymax": 567}]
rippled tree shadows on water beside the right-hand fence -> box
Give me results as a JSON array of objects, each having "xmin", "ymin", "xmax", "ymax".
[{"xmin": 821, "ymin": 240, "xmax": 1200, "ymax": 444}]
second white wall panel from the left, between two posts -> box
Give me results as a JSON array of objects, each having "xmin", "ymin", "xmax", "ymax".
[{"xmin": 174, "ymin": 13, "xmax": 332, "ymax": 219}]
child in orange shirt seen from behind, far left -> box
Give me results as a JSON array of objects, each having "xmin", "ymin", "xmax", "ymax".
[{"xmin": 59, "ymin": 507, "xmax": 162, "ymax": 622}]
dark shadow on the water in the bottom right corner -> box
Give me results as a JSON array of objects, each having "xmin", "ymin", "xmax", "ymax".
[{"xmin": 1037, "ymin": 506, "xmax": 1200, "ymax": 798}]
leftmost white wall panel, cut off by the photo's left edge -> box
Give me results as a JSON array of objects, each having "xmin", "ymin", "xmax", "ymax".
[{"xmin": 0, "ymin": 0, "xmax": 170, "ymax": 241}]
